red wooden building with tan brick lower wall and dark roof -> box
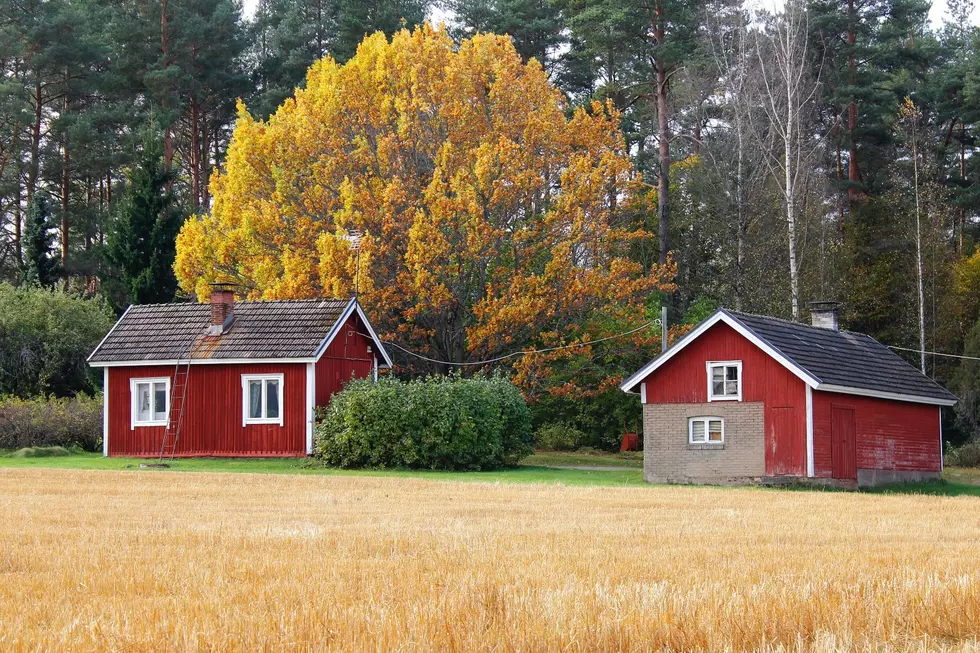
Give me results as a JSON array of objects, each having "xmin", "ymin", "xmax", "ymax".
[{"xmin": 621, "ymin": 302, "xmax": 956, "ymax": 485}]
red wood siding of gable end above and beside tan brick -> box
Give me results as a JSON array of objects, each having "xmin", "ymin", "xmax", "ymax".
[{"xmin": 644, "ymin": 322, "xmax": 806, "ymax": 476}]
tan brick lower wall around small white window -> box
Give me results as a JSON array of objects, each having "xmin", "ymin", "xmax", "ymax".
[{"xmin": 643, "ymin": 402, "xmax": 766, "ymax": 484}]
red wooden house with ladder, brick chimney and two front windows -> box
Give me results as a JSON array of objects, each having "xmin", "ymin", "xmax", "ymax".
[{"xmin": 88, "ymin": 287, "xmax": 391, "ymax": 456}]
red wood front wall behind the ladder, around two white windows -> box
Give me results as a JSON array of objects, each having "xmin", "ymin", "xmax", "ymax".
[{"xmin": 108, "ymin": 363, "xmax": 308, "ymax": 456}]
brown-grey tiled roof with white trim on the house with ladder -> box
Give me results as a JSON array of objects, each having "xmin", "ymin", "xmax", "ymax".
[{"xmin": 88, "ymin": 299, "xmax": 391, "ymax": 367}]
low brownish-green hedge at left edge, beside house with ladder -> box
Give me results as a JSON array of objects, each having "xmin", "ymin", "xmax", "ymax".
[{"xmin": 0, "ymin": 395, "xmax": 102, "ymax": 451}]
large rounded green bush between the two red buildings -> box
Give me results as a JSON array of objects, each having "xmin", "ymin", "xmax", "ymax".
[{"xmin": 314, "ymin": 376, "xmax": 532, "ymax": 470}]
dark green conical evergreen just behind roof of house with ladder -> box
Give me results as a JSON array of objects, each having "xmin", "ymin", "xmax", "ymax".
[{"xmin": 106, "ymin": 130, "xmax": 184, "ymax": 304}]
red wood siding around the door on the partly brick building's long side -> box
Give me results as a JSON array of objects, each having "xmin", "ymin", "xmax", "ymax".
[{"xmin": 813, "ymin": 390, "xmax": 942, "ymax": 478}]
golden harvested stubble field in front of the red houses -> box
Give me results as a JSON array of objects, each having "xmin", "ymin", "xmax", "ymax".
[{"xmin": 0, "ymin": 469, "xmax": 980, "ymax": 651}]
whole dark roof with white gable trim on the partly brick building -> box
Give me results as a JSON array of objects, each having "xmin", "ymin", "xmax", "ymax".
[{"xmin": 620, "ymin": 309, "xmax": 956, "ymax": 406}]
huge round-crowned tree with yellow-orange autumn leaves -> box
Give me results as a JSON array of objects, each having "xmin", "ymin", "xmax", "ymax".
[{"xmin": 175, "ymin": 25, "xmax": 674, "ymax": 393}]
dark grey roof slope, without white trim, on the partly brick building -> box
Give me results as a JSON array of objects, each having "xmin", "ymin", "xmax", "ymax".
[{"xmin": 723, "ymin": 309, "xmax": 956, "ymax": 400}]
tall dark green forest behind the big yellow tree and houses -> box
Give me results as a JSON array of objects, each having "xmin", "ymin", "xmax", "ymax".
[{"xmin": 0, "ymin": 0, "xmax": 980, "ymax": 440}]
